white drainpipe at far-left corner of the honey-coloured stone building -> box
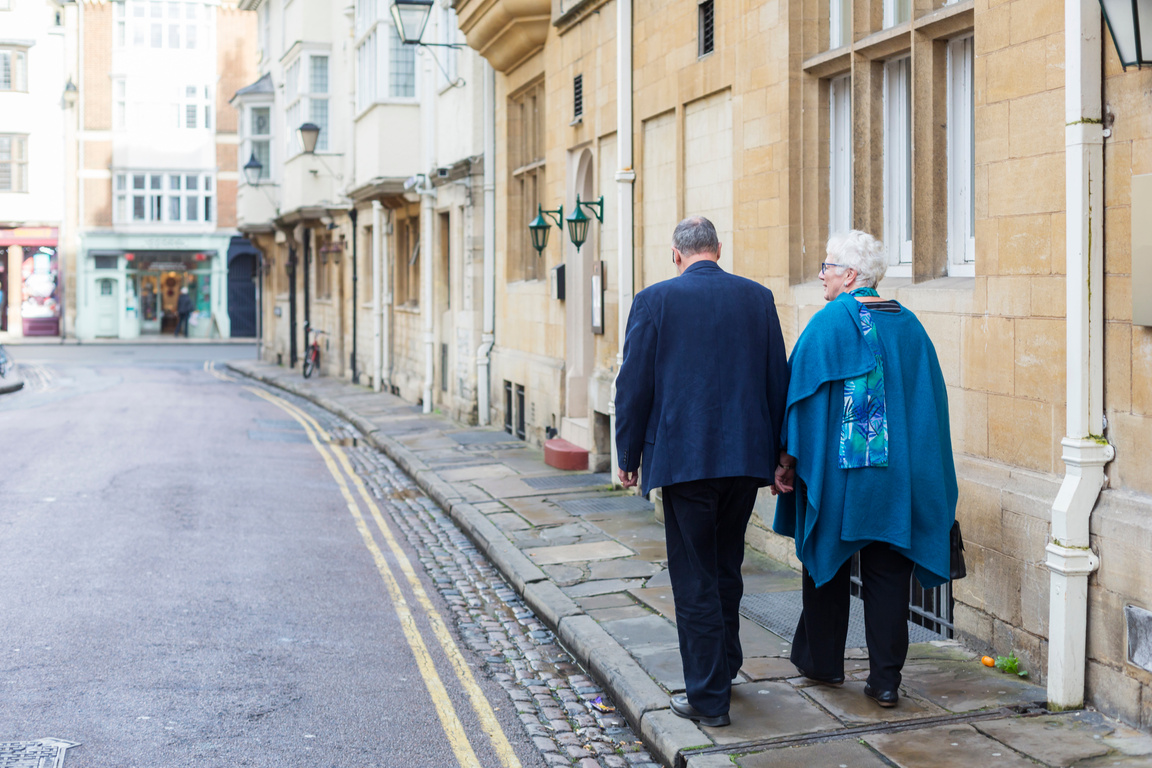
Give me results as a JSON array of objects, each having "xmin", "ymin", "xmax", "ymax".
[{"xmin": 476, "ymin": 60, "xmax": 497, "ymax": 426}]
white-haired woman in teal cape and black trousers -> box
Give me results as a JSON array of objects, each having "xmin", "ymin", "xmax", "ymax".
[{"xmin": 773, "ymin": 230, "xmax": 956, "ymax": 707}]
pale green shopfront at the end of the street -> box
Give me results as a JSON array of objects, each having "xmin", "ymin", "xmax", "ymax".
[{"xmin": 76, "ymin": 234, "xmax": 230, "ymax": 339}]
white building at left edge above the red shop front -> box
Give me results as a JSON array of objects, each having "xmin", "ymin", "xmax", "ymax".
[{"xmin": 0, "ymin": 0, "xmax": 68, "ymax": 335}]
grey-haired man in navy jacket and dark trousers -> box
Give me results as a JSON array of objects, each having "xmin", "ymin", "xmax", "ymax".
[{"xmin": 616, "ymin": 216, "xmax": 788, "ymax": 727}]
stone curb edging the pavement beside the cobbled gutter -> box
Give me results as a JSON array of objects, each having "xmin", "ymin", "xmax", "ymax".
[{"xmin": 226, "ymin": 362, "xmax": 681, "ymax": 766}]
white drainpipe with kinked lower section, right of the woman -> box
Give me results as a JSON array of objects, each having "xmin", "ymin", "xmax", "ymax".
[{"xmin": 1047, "ymin": 0, "xmax": 1115, "ymax": 710}]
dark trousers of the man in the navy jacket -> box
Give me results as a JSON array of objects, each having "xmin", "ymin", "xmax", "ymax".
[{"xmin": 664, "ymin": 478, "xmax": 759, "ymax": 716}]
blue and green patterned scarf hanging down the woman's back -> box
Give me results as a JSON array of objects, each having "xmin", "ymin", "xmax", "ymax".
[{"xmin": 840, "ymin": 288, "xmax": 888, "ymax": 470}]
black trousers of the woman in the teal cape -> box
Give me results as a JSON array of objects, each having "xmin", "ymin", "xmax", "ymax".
[{"xmin": 791, "ymin": 541, "xmax": 912, "ymax": 691}]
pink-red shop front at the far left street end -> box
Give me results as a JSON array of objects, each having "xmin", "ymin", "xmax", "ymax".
[{"xmin": 0, "ymin": 227, "xmax": 62, "ymax": 336}]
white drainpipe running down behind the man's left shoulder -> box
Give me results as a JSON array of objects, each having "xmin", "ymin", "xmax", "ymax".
[{"xmin": 608, "ymin": 0, "xmax": 636, "ymax": 484}]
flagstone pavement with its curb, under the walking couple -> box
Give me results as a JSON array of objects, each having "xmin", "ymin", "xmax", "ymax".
[{"xmin": 228, "ymin": 360, "xmax": 1152, "ymax": 768}]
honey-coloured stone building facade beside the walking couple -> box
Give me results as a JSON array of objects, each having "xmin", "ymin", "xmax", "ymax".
[{"xmin": 456, "ymin": 0, "xmax": 1152, "ymax": 727}]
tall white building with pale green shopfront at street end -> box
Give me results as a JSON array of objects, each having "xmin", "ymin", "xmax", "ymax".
[{"xmin": 75, "ymin": 0, "xmax": 255, "ymax": 339}]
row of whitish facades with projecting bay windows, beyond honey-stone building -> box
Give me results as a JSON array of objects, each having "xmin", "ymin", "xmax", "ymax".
[{"xmin": 232, "ymin": 0, "xmax": 485, "ymax": 423}]
